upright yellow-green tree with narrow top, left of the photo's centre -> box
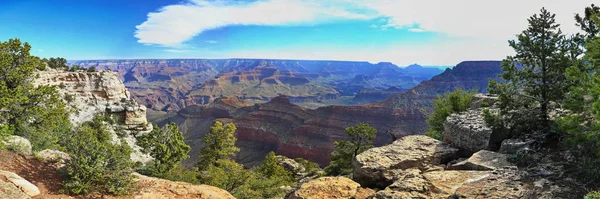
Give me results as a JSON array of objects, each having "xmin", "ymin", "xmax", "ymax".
[{"xmin": 198, "ymin": 121, "xmax": 240, "ymax": 171}]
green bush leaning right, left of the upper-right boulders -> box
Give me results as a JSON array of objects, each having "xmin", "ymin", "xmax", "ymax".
[{"xmin": 425, "ymin": 88, "xmax": 475, "ymax": 140}]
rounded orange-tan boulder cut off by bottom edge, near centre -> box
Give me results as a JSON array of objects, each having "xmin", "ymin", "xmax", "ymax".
[{"xmin": 287, "ymin": 177, "xmax": 373, "ymax": 199}]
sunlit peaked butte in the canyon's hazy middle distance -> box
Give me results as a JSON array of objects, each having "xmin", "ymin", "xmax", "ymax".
[{"xmin": 185, "ymin": 62, "xmax": 339, "ymax": 104}]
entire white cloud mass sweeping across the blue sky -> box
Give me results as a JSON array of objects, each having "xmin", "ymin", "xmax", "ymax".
[{"xmin": 135, "ymin": 0, "xmax": 594, "ymax": 65}]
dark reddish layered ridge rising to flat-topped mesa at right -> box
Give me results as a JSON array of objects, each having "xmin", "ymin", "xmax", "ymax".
[{"xmin": 151, "ymin": 61, "xmax": 501, "ymax": 166}]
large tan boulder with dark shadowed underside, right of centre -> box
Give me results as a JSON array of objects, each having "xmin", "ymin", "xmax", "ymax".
[{"xmin": 352, "ymin": 135, "xmax": 458, "ymax": 188}]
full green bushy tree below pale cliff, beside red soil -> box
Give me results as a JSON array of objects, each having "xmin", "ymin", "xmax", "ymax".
[{"xmin": 61, "ymin": 117, "xmax": 133, "ymax": 195}]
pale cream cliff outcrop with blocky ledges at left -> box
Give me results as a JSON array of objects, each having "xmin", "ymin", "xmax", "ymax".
[{"xmin": 34, "ymin": 69, "xmax": 153, "ymax": 163}]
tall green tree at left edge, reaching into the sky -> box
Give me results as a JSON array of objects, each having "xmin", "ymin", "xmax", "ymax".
[{"xmin": 0, "ymin": 39, "xmax": 70, "ymax": 150}]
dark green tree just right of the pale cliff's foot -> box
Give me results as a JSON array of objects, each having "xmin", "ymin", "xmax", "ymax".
[{"xmin": 137, "ymin": 123, "xmax": 191, "ymax": 177}]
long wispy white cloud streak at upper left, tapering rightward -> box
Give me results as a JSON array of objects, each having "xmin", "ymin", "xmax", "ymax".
[{"xmin": 135, "ymin": 0, "xmax": 369, "ymax": 46}]
